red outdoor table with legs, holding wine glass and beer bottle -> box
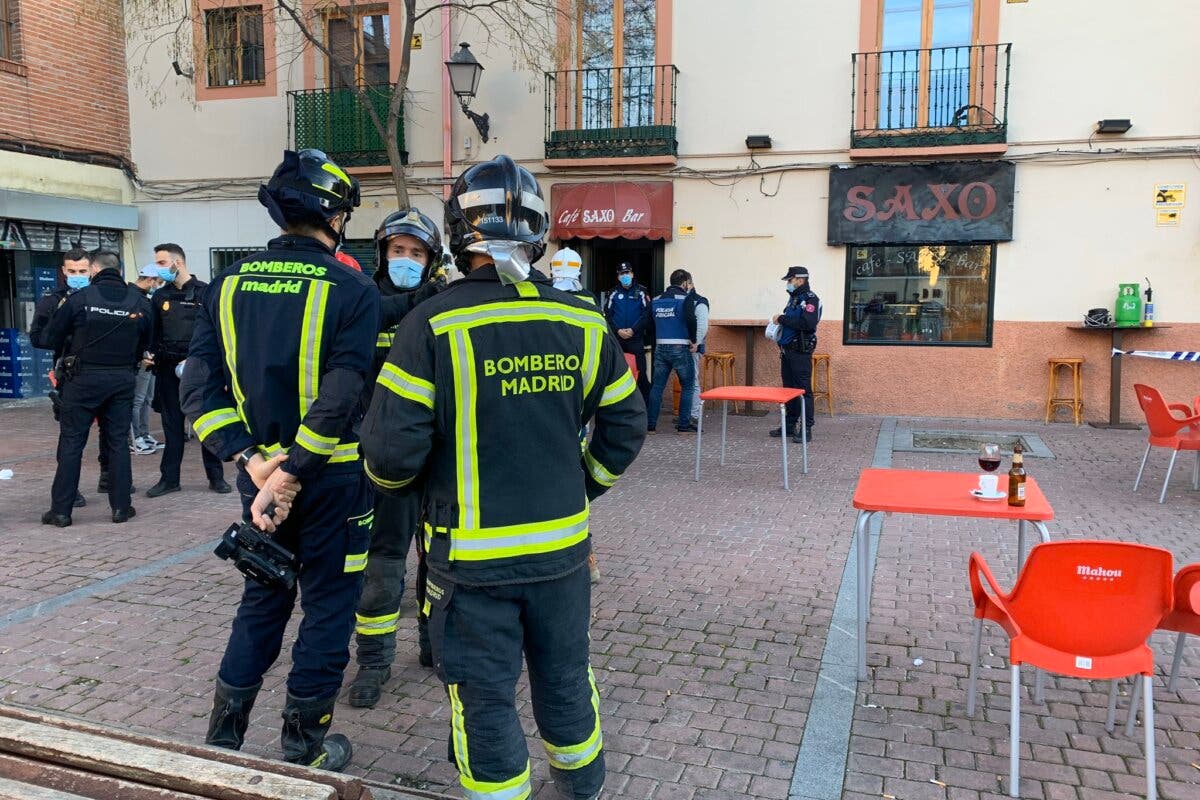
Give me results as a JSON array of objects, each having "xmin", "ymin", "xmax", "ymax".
[{"xmin": 853, "ymin": 469, "xmax": 1054, "ymax": 680}]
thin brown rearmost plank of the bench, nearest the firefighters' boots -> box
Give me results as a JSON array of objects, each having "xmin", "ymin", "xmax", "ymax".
[{"xmin": 0, "ymin": 704, "xmax": 372, "ymax": 800}]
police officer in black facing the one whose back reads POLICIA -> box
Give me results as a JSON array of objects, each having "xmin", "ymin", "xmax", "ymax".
[{"xmin": 146, "ymin": 242, "xmax": 230, "ymax": 498}]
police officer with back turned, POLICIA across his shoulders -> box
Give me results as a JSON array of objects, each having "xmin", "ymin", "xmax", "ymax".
[{"xmin": 42, "ymin": 251, "xmax": 151, "ymax": 528}]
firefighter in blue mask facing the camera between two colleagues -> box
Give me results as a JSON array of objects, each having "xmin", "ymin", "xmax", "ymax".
[{"xmin": 347, "ymin": 209, "xmax": 445, "ymax": 708}]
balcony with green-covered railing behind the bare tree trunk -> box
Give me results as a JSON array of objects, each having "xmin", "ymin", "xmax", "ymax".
[{"xmin": 288, "ymin": 86, "xmax": 408, "ymax": 167}]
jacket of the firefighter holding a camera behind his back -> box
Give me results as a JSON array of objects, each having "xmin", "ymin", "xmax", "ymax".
[{"xmin": 180, "ymin": 235, "xmax": 379, "ymax": 481}]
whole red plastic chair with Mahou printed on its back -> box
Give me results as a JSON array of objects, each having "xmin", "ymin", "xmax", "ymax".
[{"xmin": 967, "ymin": 541, "xmax": 1172, "ymax": 800}]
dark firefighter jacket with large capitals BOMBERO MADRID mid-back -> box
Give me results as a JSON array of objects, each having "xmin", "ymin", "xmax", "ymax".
[{"xmin": 362, "ymin": 265, "xmax": 646, "ymax": 585}]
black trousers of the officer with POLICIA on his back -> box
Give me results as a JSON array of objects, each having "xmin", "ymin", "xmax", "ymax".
[{"xmin": 50, "ymin": 367, "xmax": 136, "ymax": 517}]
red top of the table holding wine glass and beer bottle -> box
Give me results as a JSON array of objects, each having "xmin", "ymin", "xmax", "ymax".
[{"xmin": 854, "ymin": 469, "xmax": 1054, "ymax": 522}]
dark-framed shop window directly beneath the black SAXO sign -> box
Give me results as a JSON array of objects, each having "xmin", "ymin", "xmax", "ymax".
[{"xmin": 844, "ymin": 243, "xmax": 996, "ymax": 347}]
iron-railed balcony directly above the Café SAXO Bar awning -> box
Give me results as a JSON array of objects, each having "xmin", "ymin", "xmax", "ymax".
[{"xmin": 546, "ymin": 64, "xmax": 679, "ymax": 167}]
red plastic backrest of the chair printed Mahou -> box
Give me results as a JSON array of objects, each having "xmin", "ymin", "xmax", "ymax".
[{"xmin": 1008, "ymin": 541, "xmax": 1172, "ymax": 656}]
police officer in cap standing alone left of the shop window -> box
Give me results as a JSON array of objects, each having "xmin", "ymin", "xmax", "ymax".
[{"xmin": 770, "ymin": 266, "xmax": 822, "ymax": 443}]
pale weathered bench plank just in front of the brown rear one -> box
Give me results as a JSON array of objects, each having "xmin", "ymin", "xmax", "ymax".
[{"xmin": 0, "ymin": 720, "xmax": 337, "ymax": 800}]
